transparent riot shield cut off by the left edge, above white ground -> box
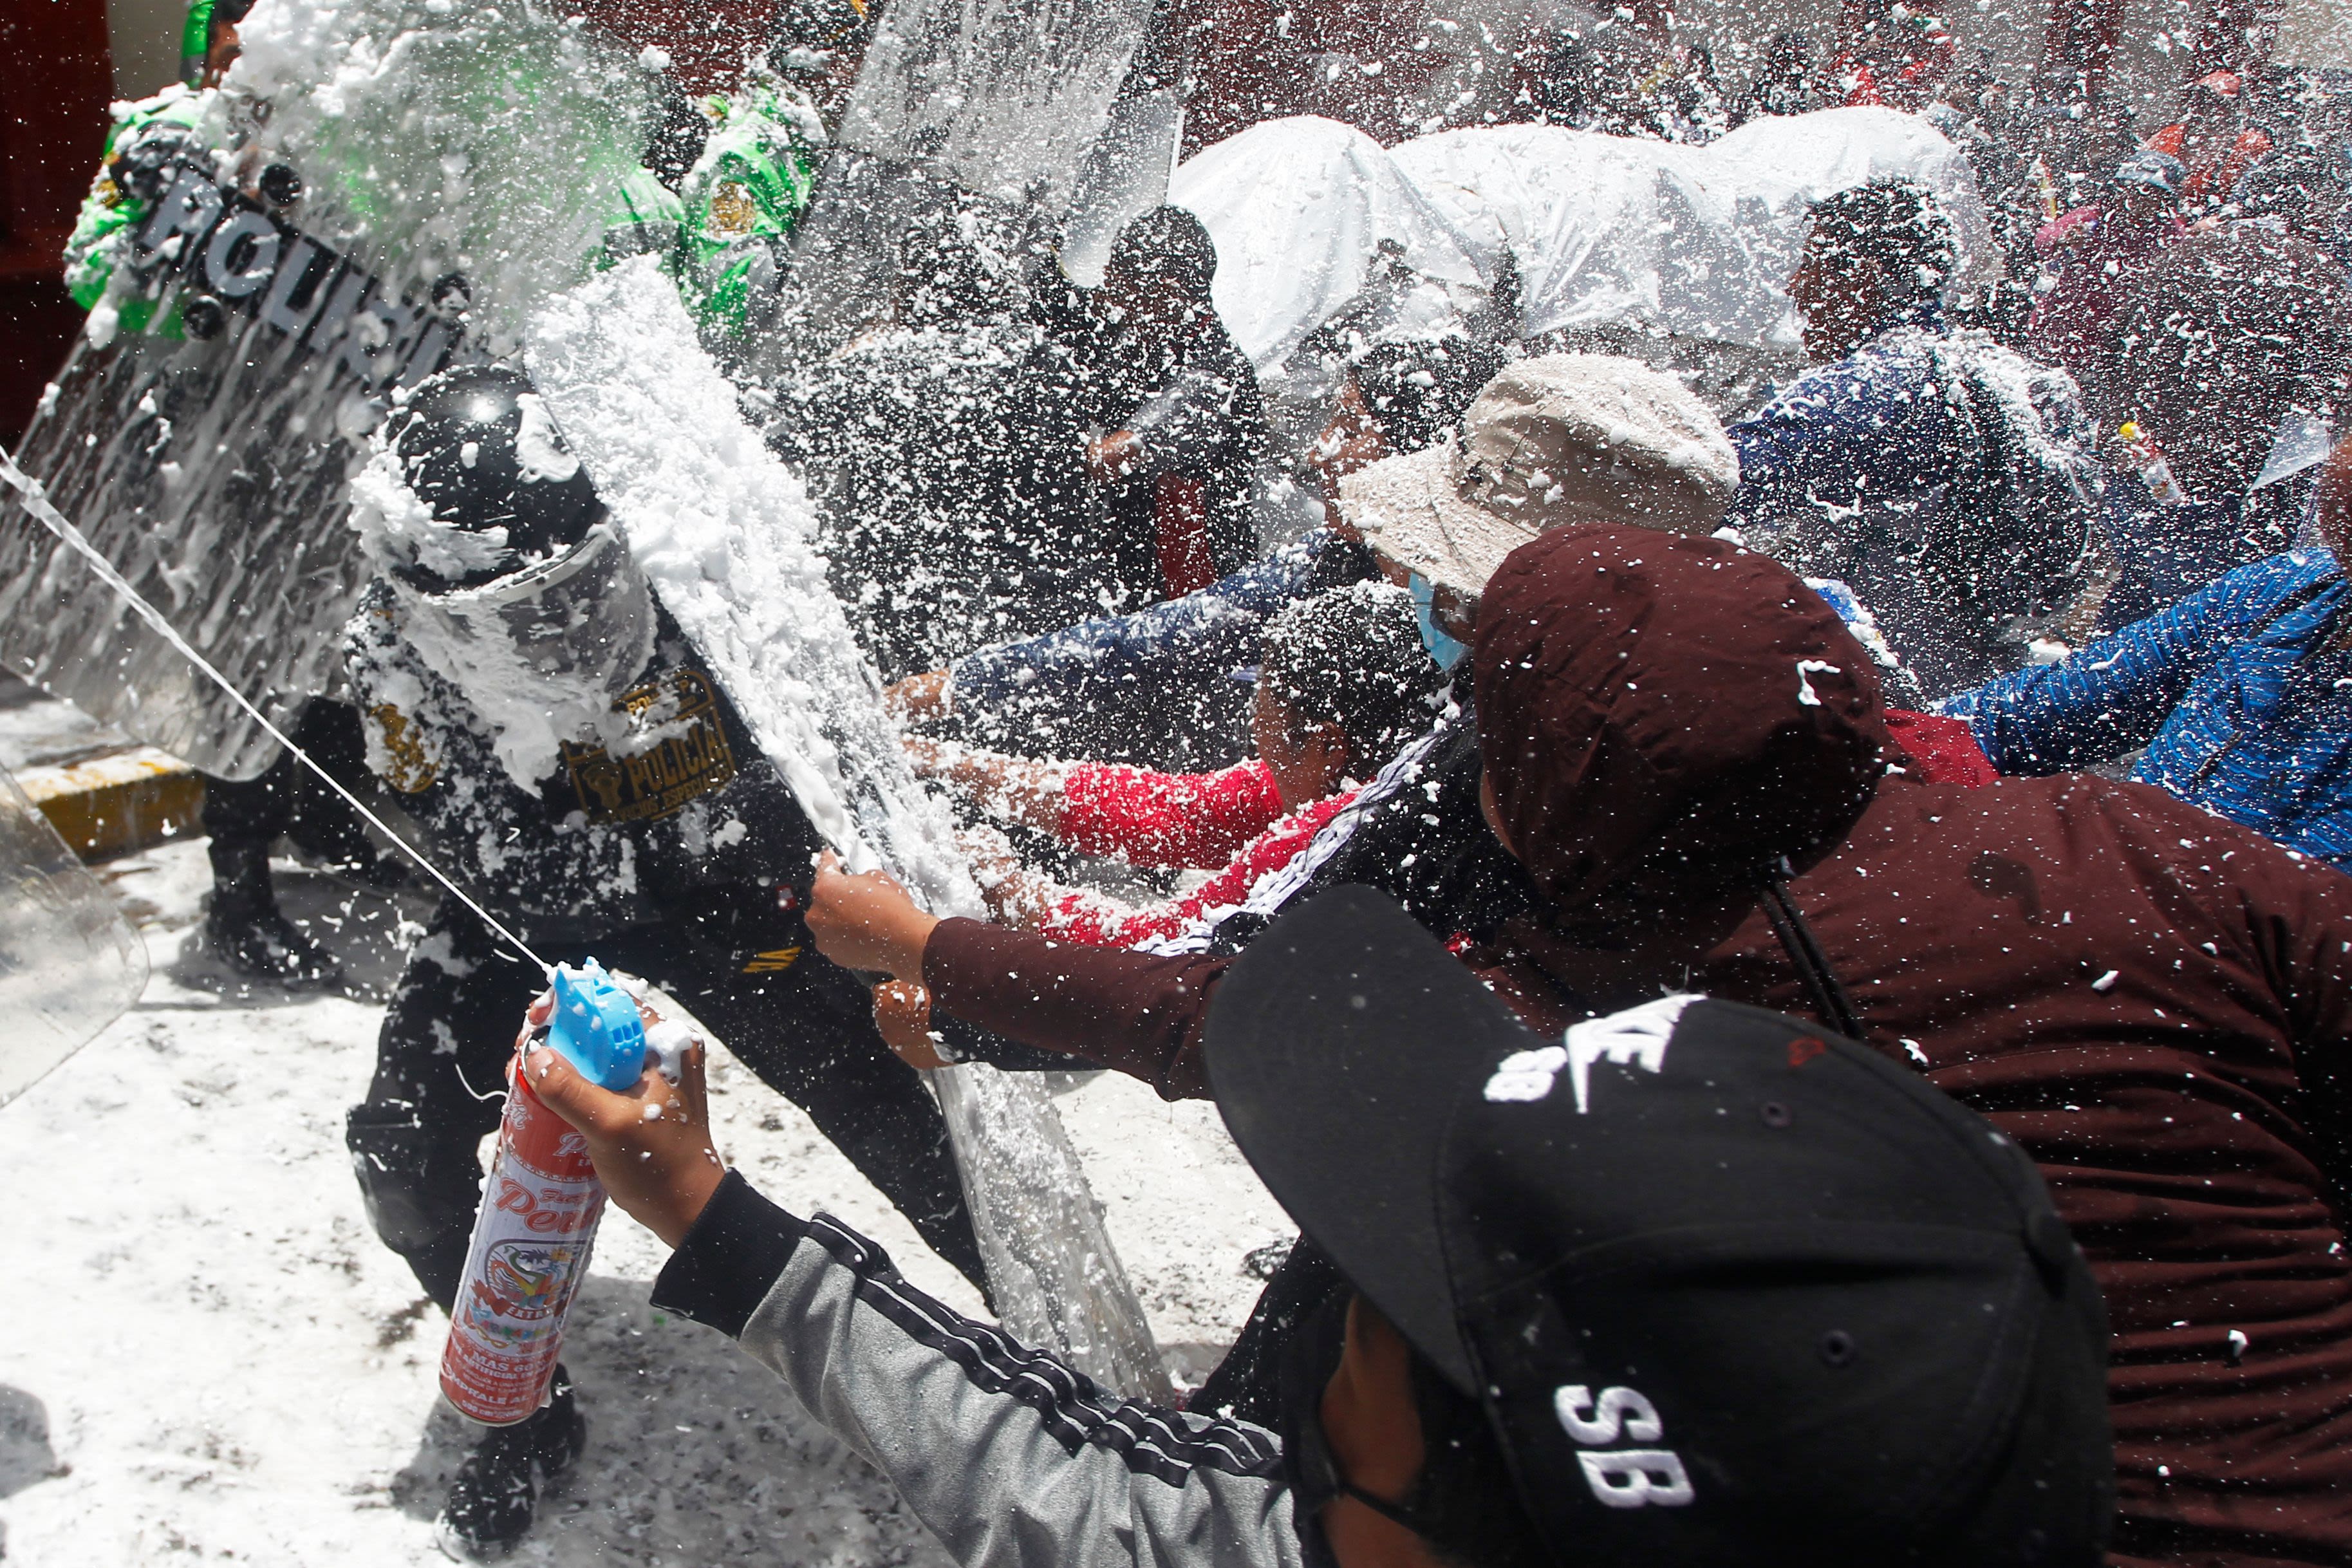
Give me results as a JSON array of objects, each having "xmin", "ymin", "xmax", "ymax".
[{"xmin": 0, "ymin": 769, "xmax": 146, "ymax": 1105}]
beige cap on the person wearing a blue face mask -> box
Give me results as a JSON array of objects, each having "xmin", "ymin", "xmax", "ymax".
[{"xmin": 1338, "ymin": 355, "xmax": 1741, "ymax": 606}]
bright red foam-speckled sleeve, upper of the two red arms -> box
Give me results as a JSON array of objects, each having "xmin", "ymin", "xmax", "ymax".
[{"xmin": 1056, "ymin": 760, "xmax": 1282, "ymax": 865}]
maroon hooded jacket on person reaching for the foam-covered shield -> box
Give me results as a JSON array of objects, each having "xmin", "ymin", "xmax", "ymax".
[{"xmin": 924, "ymin": 527, "xmax": 2352, "ymax": 1568}]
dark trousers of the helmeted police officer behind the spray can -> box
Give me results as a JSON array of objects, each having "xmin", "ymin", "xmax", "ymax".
[{"xmin": 346, "ymin": 901, "xmax": 985, "ymax": 1307}]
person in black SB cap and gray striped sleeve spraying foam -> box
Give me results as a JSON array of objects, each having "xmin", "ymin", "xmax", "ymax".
[{"xmin": 522, "ymin": 889, "xmax": 2112, "ymax": 1568}]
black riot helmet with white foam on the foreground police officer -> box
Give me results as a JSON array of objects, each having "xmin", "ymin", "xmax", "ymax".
[{"xmin": 388, "ymin": 364, "xmax": 604, "ymax": 588}]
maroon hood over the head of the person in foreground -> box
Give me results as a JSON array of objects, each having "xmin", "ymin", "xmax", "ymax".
[{"xmin": 1475, "ymin": 524, "xmax": 1903, "ymax": 908}]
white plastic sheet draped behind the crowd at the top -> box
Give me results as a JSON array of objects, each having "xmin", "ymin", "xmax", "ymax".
[{"xmin": 1169, "ymin": 108, "xmax": 1997, "ymax": 371}]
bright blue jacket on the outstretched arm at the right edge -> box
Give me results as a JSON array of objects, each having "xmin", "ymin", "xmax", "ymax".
[{"xmin": 1943, "ymin": 550, "xmax": 2352, "ymax": 870}]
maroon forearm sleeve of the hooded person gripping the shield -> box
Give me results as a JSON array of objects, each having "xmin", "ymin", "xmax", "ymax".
[{"xmin": 922, "ymin": 919, "xmax": 1233, "ymax": 1100}]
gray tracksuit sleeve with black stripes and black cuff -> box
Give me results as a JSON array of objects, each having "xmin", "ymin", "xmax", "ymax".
[{"xmin": 654, "ymin": 1175, "xmax": 1301, "ymax": 1568}]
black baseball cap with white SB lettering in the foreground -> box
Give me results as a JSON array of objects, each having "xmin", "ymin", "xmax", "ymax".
[{"xmin": 1204, "ymin": 886, "xmax": 2114, "ymax": 1568}]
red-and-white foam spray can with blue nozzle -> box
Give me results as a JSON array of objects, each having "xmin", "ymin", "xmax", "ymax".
[{"xmin": 442, "ymin": 959, "xmax": 644, "ymax": 1427}]
